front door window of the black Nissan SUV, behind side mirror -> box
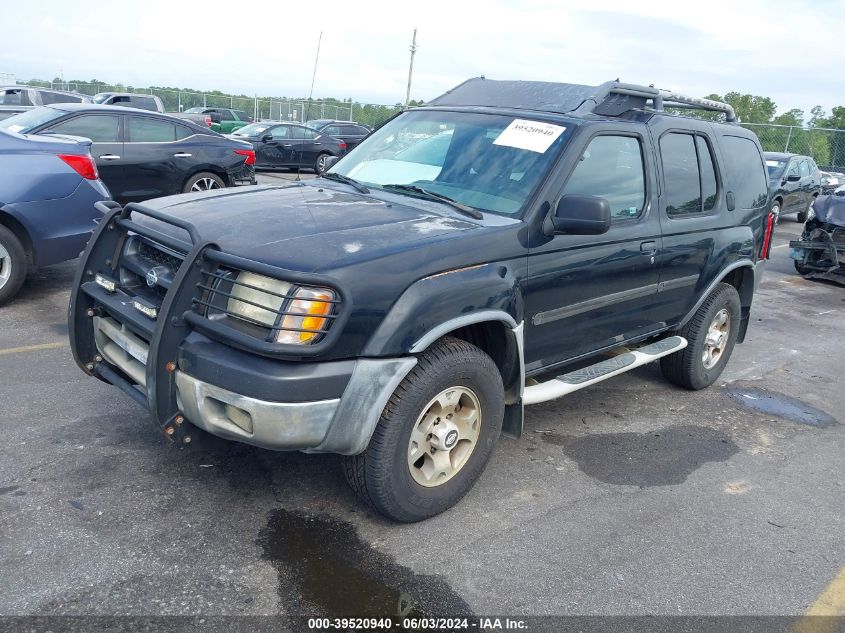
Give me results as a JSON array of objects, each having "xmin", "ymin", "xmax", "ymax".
[{"xmin": 563, "ymin": 136, "xmax": 645, "ymax": 220}]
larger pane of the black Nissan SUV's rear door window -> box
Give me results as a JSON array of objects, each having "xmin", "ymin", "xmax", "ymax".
[{"xmin": 660, "ymin": 133, "xmax": 701, "ymax": 215}]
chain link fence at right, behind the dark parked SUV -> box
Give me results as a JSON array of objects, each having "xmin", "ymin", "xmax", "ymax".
[{"xmin": 742, "ymin": 123, "xmax": 845, "ymax": 171}]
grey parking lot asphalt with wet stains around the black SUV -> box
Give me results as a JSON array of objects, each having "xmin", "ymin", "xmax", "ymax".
[{"xmin": 0, "ymin": 201, "xmax": 845, "ymax": 616}]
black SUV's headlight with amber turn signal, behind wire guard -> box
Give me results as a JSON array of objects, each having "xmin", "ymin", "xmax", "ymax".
[{"xmin": 214, "ymin": 271, "xmax": 337, "ymax": 345}]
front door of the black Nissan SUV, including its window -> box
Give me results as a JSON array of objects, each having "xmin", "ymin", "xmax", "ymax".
[{"xmin": 525, "ymin": 130, "xmax": 662, "ymax": 373}]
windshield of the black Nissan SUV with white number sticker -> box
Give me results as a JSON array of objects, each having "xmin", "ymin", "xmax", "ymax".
[{"xmin": 330, "ymin": 110, "xmax": 571, "ymax": 215}]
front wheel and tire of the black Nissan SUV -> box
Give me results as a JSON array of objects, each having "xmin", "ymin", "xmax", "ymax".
[{"xmin": 343, "ymin": 337, "xmax": 504, "ymax": 523}]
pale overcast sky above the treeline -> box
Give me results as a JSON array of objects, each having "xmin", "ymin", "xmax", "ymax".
[{"xmin": 0, "ymin": 0, "xmax": 845, "ymax": 117}]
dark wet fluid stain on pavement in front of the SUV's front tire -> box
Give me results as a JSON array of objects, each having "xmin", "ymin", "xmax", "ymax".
[{"xmin": 258, "ymin": 510, "xmax": 472, "ymax": 617}]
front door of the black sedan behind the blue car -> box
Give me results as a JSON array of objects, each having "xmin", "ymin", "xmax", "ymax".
[{"xmin": 41, "ymin": 113, "xmax": 126, "ymax": 199}]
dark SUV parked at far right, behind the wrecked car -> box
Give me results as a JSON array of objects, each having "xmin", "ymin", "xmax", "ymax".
[{"xmin": 763, "ymin": 152, "xmax": 822, "ymax": 223}]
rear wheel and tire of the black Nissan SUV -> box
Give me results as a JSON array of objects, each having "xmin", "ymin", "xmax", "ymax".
[{"xmin": 660, "ymin": 283, "xmax": 742, "ymax": 390}]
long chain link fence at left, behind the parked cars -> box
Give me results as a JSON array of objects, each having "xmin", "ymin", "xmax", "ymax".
[{"xmin": 27, "ymin": 80, "xmax": 402, "ymax": 128}]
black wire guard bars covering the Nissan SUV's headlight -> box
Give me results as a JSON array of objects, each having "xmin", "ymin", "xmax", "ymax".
[{"xmin": 193, "ymin": 266, "xmax": 341, "ymax": 344}]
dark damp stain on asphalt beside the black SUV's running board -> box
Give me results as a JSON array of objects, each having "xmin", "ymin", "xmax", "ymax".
[{"xmin": 543, "ymin": 426, "xmax": 738, "ymax": 488}]
